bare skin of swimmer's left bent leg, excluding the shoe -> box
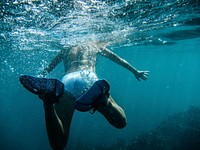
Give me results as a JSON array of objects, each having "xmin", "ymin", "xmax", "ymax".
[{"xmin": 44, "ymin": 93, "xmax": 75, "ymax": 150}]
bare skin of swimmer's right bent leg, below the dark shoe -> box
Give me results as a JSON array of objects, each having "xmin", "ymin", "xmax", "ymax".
[{"xmin": 97, "ymin": 95, "xmax": 126, "ymax": 129}]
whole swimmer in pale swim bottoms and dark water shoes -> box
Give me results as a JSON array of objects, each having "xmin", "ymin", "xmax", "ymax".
[{"xmin": 20, "ymin": 42, "xmax": 149, "ymax": 150}]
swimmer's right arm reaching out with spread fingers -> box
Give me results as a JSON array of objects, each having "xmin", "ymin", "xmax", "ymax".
[{"xmin": 100, "ymin": 48, "xmax": 149, "ymax": 81}]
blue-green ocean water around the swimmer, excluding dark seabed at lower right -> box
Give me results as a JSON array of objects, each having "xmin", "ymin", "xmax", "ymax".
[{"xmin": 0, "ymin": 0, "xmax": 200, "ymax": 150}]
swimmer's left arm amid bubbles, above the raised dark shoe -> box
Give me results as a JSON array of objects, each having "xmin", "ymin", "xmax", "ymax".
[{"xmin": 39, "ymin": 50, "xmax": 63, "ymax": 77}]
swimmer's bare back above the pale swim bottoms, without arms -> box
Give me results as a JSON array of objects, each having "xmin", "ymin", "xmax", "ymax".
[{"xmin": 63, "ymin": 45, "xmax": 98, "ymax": 73}]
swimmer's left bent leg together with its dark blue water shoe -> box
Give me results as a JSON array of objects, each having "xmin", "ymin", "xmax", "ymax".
[{"xmin": 20, "ymin": 75, "xmax": 75, "ymax": 150}]
